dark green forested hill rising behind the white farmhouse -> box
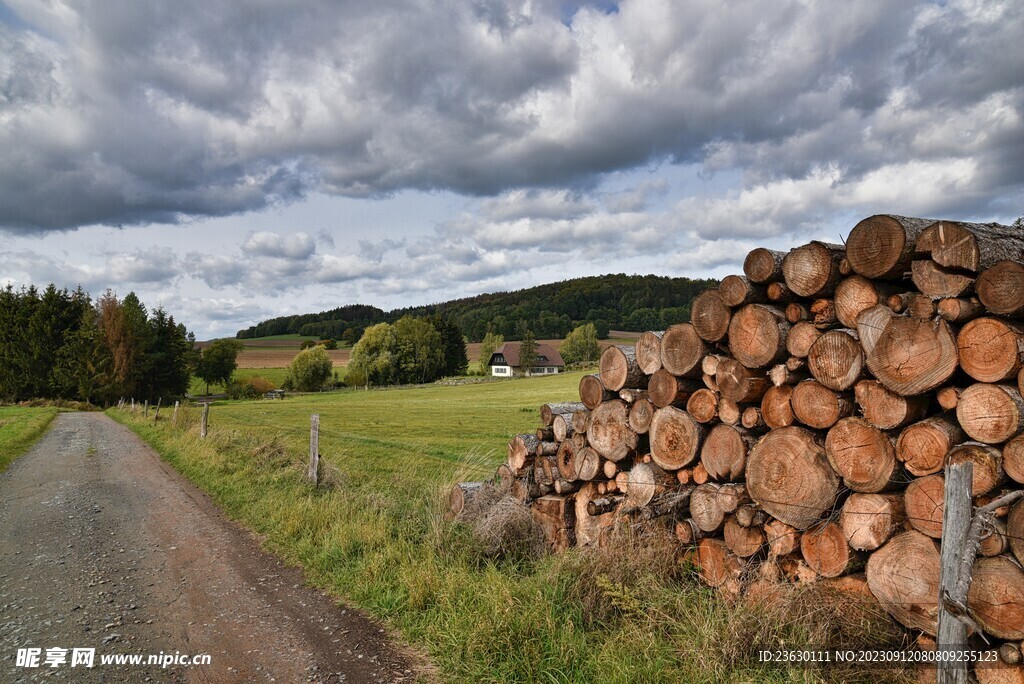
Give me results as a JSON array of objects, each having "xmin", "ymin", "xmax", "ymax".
[{"xmin": 238, "ymin": 273, "xmax": 718, "ymax": 342}]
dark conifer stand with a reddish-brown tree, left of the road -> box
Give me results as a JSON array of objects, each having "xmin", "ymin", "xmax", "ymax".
[{"xmin": 0, "ymin": 284, "xmax": 197, "ymax": 404}]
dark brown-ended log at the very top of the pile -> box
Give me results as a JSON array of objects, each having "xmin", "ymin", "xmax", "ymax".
[{"xmin": 846, "ymin": 214, "xmax": 935, "ymax": 280}]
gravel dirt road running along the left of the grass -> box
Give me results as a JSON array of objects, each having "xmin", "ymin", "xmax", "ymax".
[{"xmin": 0, "ymin": 414, "xmax": 415, "ymax": 683}]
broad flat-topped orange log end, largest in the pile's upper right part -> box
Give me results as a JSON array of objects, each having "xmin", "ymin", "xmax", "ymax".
[{"xmin": 867, "ymin": 309, "xmax": 958, "ymax": 396}]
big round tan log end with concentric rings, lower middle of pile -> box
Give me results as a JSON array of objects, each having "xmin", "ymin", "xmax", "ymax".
[{"xmin": 746, "ymin": 427, "xmax": 840, "ymax": 529}]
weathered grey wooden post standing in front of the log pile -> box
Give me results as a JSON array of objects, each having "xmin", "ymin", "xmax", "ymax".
[{"xmin": 936, "ymin": 461, "xmax": 978, "ymax": 684}]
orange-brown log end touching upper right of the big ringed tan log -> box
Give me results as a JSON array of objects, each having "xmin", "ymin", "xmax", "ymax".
[{"xmin": 825, "ymin": 417, "xmax": 902, "ymax": 494}]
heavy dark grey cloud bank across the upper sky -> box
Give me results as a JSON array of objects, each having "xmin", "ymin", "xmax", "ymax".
[{"xmin": 0, "ymin": 0, "xmax": 1024, "ymax": 232}]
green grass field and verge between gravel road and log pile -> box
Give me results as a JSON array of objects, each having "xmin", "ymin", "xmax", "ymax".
[{"xmin": 110, "ymin": 374, "xmax": 896, "ymax": 683}]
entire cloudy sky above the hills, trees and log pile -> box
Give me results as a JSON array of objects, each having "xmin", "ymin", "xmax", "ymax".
[{"xmin": 0, "ymin": 0, "xmax": 1024, "ymax": 339}]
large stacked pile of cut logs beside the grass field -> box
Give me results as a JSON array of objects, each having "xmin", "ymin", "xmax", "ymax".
[{"xmin": 454, "ymin": 215, "xmax": 1024, "ymax": 678}]
